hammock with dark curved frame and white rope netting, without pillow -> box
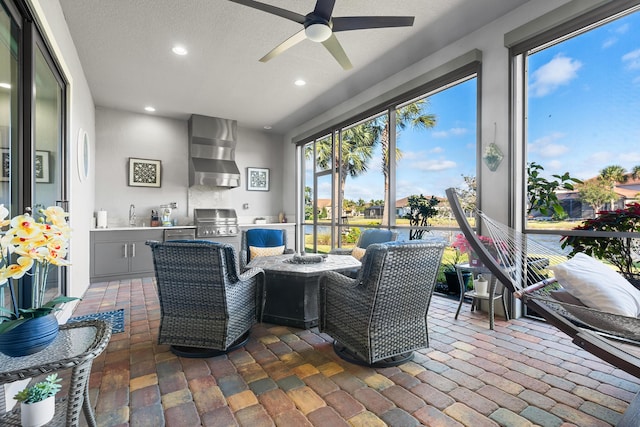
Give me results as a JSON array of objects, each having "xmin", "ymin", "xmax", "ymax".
[{"xmin": 446, "ymin": 188, "xmax": 640, "ymax": 384}]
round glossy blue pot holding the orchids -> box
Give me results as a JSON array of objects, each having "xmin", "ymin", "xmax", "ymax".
[{"xmin": 0, "ymin": 313, "xmax": 60, "ymax": 357}]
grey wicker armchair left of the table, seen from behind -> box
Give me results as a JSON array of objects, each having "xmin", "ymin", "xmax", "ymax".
[{"xmin": 147, "ymin": 240, "xmax": 264, "ymax": 357}]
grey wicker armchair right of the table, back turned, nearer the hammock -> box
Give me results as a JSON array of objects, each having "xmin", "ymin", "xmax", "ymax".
[{"xmin": 320, "ymin": 239, "xmax": 446, "ymax": 367}]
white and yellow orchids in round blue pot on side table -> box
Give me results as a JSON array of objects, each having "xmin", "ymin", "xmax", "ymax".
[{"xmin": 0, "ymin": 205, "xmax": 77, "ymax": 356}]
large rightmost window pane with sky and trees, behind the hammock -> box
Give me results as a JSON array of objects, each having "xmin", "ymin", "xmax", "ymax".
[{"xmin": 526, "ymin": 8, "xmax": 640, "ymax": 229}]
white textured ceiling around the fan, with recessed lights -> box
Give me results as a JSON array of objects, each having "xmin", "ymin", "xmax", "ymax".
[{"xmin": 60, "ymin": 0, "xmax": 527, "ymax": 134}]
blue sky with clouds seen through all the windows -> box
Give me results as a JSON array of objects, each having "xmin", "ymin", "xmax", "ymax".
[{"xmin": 312, "ymin": 12, "xmax": 640, "ymax": 201}]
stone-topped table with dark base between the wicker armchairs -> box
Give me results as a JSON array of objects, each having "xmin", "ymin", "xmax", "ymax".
[{"xmin": 247, "ymin": 254, "xmax": 361, "ymax": 329}]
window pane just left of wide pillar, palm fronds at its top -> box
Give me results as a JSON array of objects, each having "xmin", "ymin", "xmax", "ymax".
[{"xmin": 396, "ymin": 78, "xmax": 477, "ymax": 239}]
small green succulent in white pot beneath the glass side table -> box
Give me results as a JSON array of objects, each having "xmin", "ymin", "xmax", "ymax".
[{"xmin": 13, "ymin": 374, "xmax": 62, "ymax": 427}]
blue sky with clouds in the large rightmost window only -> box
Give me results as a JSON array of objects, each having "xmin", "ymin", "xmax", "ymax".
[{"xmin": 528, "ymin": 13, "xmax": 640, "ymax": 179}]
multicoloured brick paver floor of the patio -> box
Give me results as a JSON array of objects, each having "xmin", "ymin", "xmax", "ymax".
[{"xmin": 74, "ymin": 278, "xmax": 640, "ymax": 427}]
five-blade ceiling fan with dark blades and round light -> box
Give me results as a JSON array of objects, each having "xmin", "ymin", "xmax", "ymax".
[{"xmin": 230, "ymin": 0, "xmax": 414, "ymax": 70}]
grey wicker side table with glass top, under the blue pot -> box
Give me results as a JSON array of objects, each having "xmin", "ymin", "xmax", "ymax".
[{"xmin": 0, "ymin": 320, "xmax": 111, "ymax": 427}]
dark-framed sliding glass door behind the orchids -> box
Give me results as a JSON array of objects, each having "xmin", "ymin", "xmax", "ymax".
[{"xmin": 0, "ymin": 0, "xmax": 68, "ymax": 305}]
